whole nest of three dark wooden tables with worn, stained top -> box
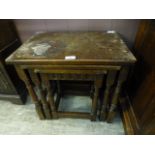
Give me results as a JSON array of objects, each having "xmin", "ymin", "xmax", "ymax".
[{"xmin": 6, "ymin": 31, "xmax": 136, "ymax": 122}]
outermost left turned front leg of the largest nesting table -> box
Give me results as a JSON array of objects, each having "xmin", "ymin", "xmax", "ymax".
[{"xmin": 16, "ymin": 67, "xmax": 45, "ymax": 119}]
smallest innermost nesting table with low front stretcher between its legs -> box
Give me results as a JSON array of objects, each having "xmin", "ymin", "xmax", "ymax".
[{"xmin": 38, "ymin": 70, "xmax": 105, "ymax": 121}]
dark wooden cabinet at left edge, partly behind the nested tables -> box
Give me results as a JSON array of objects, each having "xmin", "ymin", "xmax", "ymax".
[{"xmin": 0, "ymin": 20, "xmax": 27, "ymax": 104}]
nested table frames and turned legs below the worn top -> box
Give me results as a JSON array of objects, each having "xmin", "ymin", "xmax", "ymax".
[{"xmin": 16, "ymin": 65, "xmax": 128, "ymax": 122}]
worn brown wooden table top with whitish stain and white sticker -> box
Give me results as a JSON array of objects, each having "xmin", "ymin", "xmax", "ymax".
[{"xmin": 6, "ymin": 31, "xmax": 136, "ymax": 64}]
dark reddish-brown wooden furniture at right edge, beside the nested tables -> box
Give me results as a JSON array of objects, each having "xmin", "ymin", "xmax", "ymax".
[{"xmin": 123, "ymin": 20, "xmax": 155, "ymax": 134}]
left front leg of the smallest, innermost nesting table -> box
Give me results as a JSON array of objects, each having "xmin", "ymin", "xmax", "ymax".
[{"xmin": 41, "ymin": 74, "xmax": 58, "ymax": 118}]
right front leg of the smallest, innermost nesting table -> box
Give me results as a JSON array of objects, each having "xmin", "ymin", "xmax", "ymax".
[{"xmin": 91, "ymin": 79, "xmax": 102, "ymax": 121}]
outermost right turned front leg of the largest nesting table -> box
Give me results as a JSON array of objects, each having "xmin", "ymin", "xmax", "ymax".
[{"xmin": 107, "ymin": 67, "xmax": 128, "ymax": 123}]
